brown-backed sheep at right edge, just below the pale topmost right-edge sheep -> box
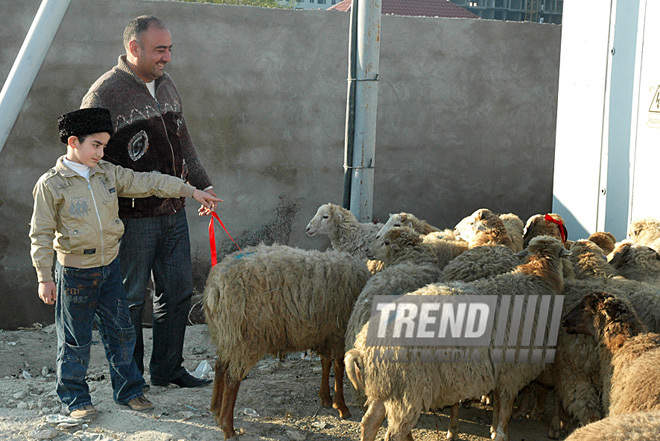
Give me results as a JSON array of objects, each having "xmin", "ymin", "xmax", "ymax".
[{"xmin": 608, "ymin": 242, "xmax": 660, "ymax": 287}]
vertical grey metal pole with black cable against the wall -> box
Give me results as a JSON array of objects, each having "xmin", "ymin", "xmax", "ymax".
[{"xmin": 349, "ymin": 0, "xmax": 381, "ymax": 222}]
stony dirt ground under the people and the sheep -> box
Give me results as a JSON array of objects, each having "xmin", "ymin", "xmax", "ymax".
[{"xmin": 0, "ymin": 325, "xmax": 564, "ymax": 441}]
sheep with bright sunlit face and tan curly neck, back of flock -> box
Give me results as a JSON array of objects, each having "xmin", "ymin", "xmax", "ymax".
[{"xmin": 454, "ymin": 208, "xmax": 522, "ymax": 252}]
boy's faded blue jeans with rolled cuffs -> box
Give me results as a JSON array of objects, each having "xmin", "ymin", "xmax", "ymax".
[{"xmin": 55, "ymin": 259, "xmax": 144, "ymax": 411}]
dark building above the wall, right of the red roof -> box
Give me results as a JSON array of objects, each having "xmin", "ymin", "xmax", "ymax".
[{"xmin": 451, "ymin": 0, "xmax": 564, "ymax": 24}]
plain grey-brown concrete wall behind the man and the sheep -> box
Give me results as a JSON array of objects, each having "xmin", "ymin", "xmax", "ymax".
[{"xmin": 0, "ymin": 0, "xmax": 560, "ymax": 328}]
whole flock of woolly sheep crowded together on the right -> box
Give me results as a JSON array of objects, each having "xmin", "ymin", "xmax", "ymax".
[{"xmin": 203, "ymin": 203, "xmax": 660, "ymax": 441}]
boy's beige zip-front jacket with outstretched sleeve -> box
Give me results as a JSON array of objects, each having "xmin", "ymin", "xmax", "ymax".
[{"xmin": 30, "ymin": 156, "xmax": 195, "ymax": 282}]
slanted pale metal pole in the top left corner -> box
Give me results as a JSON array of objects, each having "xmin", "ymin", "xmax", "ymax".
[{"xmin": 0, "ymin": 0, "xmax": 71, "ymax": 152}]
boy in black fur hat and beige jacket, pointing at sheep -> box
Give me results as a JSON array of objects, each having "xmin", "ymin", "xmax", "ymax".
[{"xmin": 30, "ymin": 108, "xmax": 221, "ymax": 419}]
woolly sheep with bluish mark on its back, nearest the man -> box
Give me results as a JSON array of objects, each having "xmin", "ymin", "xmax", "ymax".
[{"xmin": 204, "ymin": 244, "xmax": 370, "ymax": 438}]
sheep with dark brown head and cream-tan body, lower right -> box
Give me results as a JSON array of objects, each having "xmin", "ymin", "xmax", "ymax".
[{"xmin": 562, "ymin": 292, "xmax": 660, "ymax": 416}]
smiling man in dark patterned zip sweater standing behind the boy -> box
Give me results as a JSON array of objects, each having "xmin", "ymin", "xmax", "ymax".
[{"xmin": 81, "ymin": 16, "xmax": 215, "ymax": 387}]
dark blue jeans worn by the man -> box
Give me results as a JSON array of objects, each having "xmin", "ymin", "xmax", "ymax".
[{"xmin": 119, "ymin": 210, "xmax": 193, "ymax": 382}]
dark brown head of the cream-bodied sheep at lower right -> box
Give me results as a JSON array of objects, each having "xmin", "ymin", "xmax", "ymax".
[{"xmin": 562, "ymin": 292, "xmax": 638, "ymax": 338}]
